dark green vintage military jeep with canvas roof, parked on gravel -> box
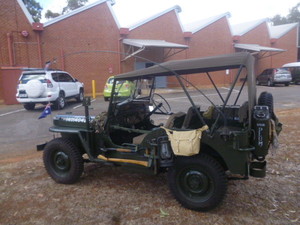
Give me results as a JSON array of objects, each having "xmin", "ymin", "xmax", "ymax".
[{"xmin": 38, "ymin": 53, "xmax": 281, "ymax": 211}]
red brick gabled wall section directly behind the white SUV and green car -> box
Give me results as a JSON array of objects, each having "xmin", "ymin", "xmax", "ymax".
[{"xmin": 42, "ymin": 3, "xmax": 119, "ymax": 93}]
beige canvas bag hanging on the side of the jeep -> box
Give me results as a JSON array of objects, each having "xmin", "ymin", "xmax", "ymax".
[{"xmin": 162, "ymin": 125, "xmax": 208, "ymax": 156}]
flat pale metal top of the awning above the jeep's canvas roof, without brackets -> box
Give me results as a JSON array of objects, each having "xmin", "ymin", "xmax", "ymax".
[{"xmin": 123, "ymin": 39, "xmax": 189, "ymax": 49}]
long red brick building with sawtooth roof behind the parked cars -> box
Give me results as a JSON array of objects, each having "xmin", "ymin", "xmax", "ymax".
[{"xmin": 0, "ymin": 0, "xmax": 298, "ymax": 104}]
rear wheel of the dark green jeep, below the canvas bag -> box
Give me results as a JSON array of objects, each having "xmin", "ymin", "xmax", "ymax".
[{"xmin": 168, "ymin": 154, "xmax": 227, "ymax": 211}]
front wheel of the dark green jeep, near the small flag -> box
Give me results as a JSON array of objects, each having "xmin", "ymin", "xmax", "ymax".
[{"xmin": 43, "ymin": 138, "xmax": 83, "ymax": 184}]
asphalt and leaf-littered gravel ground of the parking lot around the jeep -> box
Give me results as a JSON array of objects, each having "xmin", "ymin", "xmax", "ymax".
[{"xmin": 0, "ymin": 85, "xmax": 300, "ymax": 224}]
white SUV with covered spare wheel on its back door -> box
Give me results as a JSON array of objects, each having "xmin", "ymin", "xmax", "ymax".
[{"xmin": 16, "ymin": 69, "xmax": 83, "ymax": 110}]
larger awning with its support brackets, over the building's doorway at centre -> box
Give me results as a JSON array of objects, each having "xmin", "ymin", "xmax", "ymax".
[{"xmin": 123, "ymin": 39, "xmax": 189, "ymax": 61}]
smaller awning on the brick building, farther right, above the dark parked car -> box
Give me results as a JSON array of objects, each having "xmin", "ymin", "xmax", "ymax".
[{"xmin": 234, "ymin": 44, "xmax": 286, "ymax": 58}]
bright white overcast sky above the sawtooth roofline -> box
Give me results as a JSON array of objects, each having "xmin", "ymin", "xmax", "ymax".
[{"xmin": 36, "ymin": 0, "xmax": 300, "ymax": 27}]
